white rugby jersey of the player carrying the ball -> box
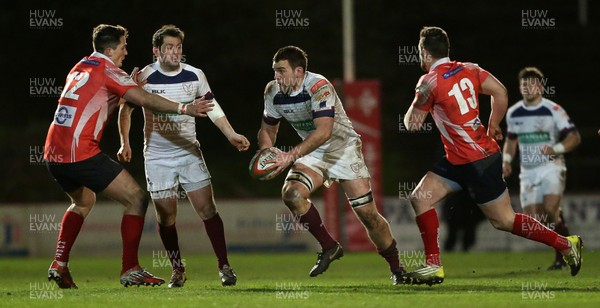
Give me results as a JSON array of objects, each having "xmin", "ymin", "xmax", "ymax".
[{"xmin": 263, "ymin": 71, "xmax": 360, "ymax": 153}]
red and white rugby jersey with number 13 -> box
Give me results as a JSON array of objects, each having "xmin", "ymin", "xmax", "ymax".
[{"xmin": 412, "ymin": 58, "xmax": 500, "ymax": 165}]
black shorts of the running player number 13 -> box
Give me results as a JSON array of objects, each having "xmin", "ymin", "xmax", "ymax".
[{"xmin": 430, "ymin": 152, "xmax": 506, "ymax": 204}]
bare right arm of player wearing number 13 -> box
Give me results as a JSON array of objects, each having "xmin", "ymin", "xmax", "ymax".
[{"xmin": 481, "ymin": 74, "xmax": 508, "ymax": 140}]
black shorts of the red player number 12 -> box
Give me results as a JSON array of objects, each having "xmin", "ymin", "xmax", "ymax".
[{"xmin": 46, "ymin": 153, "xmax": 123, "ymax": 193}]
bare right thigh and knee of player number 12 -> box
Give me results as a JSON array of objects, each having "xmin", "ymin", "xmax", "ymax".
[{"xmin": 102, "ymin": 169, "xmax": 146, "ymax": 207}]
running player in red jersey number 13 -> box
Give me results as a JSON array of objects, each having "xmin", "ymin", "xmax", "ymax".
[{"xmin": 404, "ymin": 27, "xmax": 583, "ymax": 285}]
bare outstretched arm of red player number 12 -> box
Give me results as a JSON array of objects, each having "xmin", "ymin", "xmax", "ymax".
[{"xmin": 123, "ymin": 87, "xmax": 213, "ymax": 117}]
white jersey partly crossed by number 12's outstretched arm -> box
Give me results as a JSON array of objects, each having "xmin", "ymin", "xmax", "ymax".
[{"xmin": 140, "ymin": 62, "xmax": 213, "ymax": 160}]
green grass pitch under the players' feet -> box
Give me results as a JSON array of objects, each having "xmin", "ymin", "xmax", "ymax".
[{"xmin": 0, "ymin": 251, "xmax": 600, "ymax": 307}]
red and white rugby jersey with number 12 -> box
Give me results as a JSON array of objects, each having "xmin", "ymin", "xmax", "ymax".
[{"xmin": 44, "ymin": 52, "xmax": 137, "ymax": 163}]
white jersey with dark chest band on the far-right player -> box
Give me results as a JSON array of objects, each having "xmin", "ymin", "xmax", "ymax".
[{"xmin": 506, "ymin": 98, "xmax": 576, "ymax": 169}]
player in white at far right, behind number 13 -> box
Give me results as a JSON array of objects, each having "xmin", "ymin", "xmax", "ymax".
[{"xmin": 502, "ymin": 67, "xmax": 581, "ymax": 270}]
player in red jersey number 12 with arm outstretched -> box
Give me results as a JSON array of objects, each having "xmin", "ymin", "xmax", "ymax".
[{"xmin": 44, "ymin": 24, "xmax": 212, "ymax": 289}]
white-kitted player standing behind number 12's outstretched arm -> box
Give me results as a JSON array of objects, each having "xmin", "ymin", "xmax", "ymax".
[{"xmin": 118, "ymin": 25, "xmax": 250, "ymax": 288}]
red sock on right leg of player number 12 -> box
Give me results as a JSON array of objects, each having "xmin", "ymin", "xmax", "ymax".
[{"xmin": 121, "ymin": 215, "xmax": 144, "ymax": 275}]
